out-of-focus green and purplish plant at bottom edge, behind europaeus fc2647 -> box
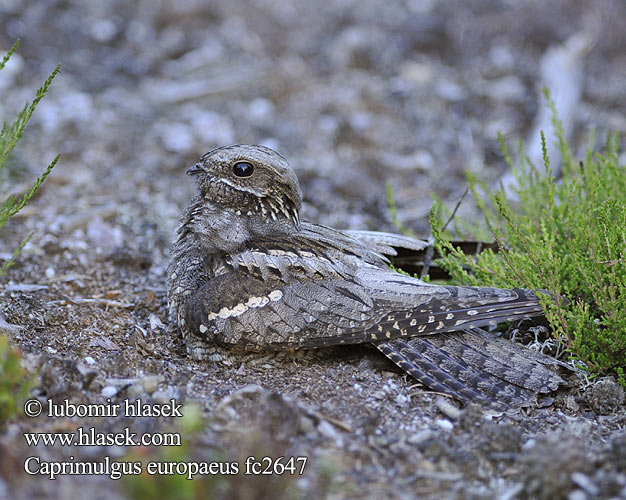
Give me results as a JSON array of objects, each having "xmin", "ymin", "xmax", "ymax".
[{"xmin": 121, "ymin": 405, "xmax": 342, "ymax": 500}]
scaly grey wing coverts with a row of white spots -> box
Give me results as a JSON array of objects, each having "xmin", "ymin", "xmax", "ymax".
[{"xmin": 185, "ymin": 269, "xmax": 378, "ymax": 350}]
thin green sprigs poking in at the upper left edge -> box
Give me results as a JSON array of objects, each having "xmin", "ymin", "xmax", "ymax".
[{"xmin": 0, "ymin": 40, "xmax": 60, "ymax": 276}]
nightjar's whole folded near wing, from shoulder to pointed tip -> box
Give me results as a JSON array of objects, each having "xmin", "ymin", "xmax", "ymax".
[{"xmin": 185, "ymin": 232, "xmax": 542, "ymax": 350}]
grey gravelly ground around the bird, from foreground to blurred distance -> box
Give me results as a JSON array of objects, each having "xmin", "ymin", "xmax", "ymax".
[{"xmin": 0, "ymin": 0, "xmax": 626, "ymax": 500}]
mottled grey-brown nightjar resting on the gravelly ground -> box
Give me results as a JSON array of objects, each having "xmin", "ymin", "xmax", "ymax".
[{"xmin": 168, "ymin": 145, "xmax": 562, "ymax": 407}]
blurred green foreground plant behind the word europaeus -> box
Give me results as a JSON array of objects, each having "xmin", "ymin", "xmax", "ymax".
[{"xmin": 122, "ymin": 405, "xmax": 312, "ymax": 500}]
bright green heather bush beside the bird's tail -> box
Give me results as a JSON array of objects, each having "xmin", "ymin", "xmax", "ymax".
[{"xmin": 430, "ymin": 91, "xmax": 626, "ymax": 386}]
